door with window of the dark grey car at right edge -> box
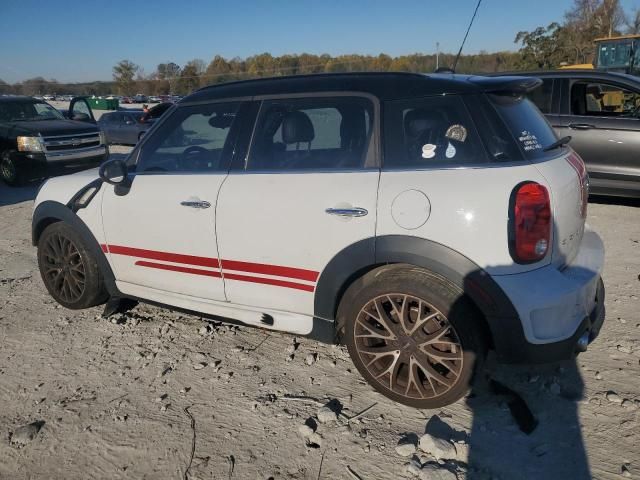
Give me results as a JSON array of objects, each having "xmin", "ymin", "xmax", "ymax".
[{"xmin": 551, "ymin": 78, "xmax": 640, "ymax": 188}]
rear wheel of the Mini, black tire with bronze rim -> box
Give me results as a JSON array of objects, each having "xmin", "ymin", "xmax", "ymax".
[{"xmin": 337, "ymin": 265, "xmax": 487, "ymax": 409}]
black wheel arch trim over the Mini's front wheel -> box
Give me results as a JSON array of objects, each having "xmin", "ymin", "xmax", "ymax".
[{"xmin": 31, "ymin": 200, "xmax": 123, "ymax": 297}]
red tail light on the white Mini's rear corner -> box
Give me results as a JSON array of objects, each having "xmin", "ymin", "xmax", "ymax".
[{"xmin": 509, "ymin": 182, "xmax": 553, "ymax": 263}]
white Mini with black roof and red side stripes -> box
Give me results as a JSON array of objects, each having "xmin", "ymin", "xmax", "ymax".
[{"xmin": 33, "ymin": 73, "xmax": 604, "ymax": 408}]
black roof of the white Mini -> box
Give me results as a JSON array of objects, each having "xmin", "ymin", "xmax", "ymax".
[{"xmin": 180, "ymin": 72, "xmax": 539, "ymax": 104}]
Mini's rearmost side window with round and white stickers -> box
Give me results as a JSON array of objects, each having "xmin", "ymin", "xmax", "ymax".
[{"xmin": 384, "ymin": 96, "xmax": 487, "ymax": 169}]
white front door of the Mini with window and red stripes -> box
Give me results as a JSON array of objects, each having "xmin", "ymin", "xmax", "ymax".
[{"xmin": 102, "ymin": 102, "xmax": 246, "ymax": 304}]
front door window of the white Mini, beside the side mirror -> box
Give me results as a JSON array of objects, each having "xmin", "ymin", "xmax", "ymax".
[{"xmin": 135, "ymin": 102, "xmax": 240, "ymax": 173}]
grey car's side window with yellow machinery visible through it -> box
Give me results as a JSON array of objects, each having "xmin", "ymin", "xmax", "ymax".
[{"xmin": 571, "ymin": 82, "xmax": 640, "ymax": 117}]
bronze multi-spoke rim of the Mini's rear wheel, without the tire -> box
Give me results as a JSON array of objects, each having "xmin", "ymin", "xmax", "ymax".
[{"xmin": 354, "ymin": 294, "xmax": 463, "ymax": 400}]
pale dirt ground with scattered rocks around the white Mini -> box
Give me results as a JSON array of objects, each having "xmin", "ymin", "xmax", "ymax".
[{"xmin": 0, "ymin": 147, "xmax": 640, "ymax": 480}]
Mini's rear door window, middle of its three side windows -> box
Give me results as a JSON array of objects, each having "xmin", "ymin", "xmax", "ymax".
[{"xmin": 246, "ymin": 97, "xmax": 375, "ymax": 171}]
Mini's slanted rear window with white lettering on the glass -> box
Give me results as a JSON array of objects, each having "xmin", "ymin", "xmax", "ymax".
[{"xmin": 489, "ymin": 94, "xmax": 558, "ymax": 160}]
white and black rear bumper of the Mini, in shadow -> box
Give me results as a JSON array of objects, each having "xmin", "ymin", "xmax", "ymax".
[{"xmin": 493, "ymin": 229, "xmax": 605, "ymax": 363}]
